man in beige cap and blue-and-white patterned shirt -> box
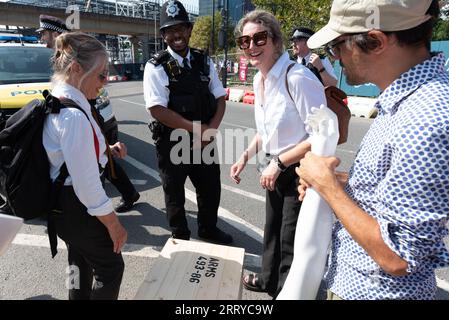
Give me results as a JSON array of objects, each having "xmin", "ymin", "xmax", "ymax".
[{"xmin": 297, "ymin": 0, "xmax": 449, "ymax": 300}]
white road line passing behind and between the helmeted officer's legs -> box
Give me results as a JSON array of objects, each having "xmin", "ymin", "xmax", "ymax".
[{"xmin": 124, "ymin": 155, "xmax": 263, "ymax": 242}]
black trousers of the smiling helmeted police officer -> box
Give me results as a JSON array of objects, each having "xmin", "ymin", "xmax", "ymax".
[{"xmin": 156, "ymin": 139, "xmax": 221, "ymax": 236}]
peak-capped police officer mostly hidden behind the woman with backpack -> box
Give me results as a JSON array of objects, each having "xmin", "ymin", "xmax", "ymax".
[{"xmin": 37, "ymin": 14, "xmax": 140, "ymax": 213}]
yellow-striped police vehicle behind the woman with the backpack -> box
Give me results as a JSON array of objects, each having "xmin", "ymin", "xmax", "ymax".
[{"xmin": 0, "ymin": 33, "xmax": 118, "ymax": 144}]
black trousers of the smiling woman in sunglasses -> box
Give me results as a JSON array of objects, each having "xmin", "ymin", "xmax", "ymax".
[{"xmin": 260, "ymin": 164, "xmax": 301, "ymax": 296}]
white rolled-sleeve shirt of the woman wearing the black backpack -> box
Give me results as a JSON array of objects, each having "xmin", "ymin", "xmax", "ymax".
[{"xmin": 43, "ymin": 83, "xmax": 114, "ymax": 216}]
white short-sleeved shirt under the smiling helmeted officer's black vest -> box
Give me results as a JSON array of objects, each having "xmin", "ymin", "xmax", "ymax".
[{"xmin": 143, "ymin": 47, "xmax": 226, "ymax": 110}]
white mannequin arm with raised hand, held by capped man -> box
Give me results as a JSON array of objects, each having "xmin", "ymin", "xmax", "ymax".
[{"xmin": 277, "ymin": 105, "xmax": 339, "ymax": 300}]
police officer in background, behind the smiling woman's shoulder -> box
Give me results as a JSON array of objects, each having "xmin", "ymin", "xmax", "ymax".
[{"xmin": 290, "ymin": 27, "xmax": 337, "ymax": 87}]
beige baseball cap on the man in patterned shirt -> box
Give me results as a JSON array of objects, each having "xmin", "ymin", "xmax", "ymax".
[{"xmin": 307, "ymin": 0, "xmax": 432, "ymax": 49}]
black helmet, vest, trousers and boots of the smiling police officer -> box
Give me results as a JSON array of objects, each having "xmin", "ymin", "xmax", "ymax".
[{"xmin": 149, "ymin": 0, "xmax": 232, "ymax": 244}]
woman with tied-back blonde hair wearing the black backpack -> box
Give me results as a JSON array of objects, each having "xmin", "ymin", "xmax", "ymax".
[{"xmin": 43, "ymin": 32, "xmax": 127, "ymax": 300}]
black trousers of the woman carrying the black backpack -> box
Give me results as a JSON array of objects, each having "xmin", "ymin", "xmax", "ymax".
[{"xmin": 52, "ymin": 186, "xmax": 125, "ymax": 300}]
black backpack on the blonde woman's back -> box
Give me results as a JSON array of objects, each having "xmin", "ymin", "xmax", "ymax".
[{"xmin": 0, "ymin": 90, "xmax": 89, "ymax": 220}]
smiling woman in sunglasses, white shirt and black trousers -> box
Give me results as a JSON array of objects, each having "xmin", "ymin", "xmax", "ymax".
[{"xmin": 230, "ymin": 10, "xmax": 326, "ymax": 296}]
